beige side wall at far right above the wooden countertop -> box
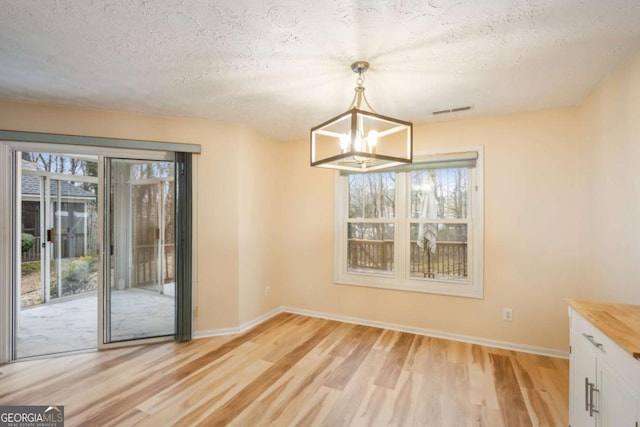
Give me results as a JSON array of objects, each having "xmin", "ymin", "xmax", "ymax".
[{"xmin": 580, "ymin": 54, "xmax": 640, "ymax": 304}]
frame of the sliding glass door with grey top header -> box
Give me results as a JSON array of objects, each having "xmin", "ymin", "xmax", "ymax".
[{"xmin": 0, "ymin": 138, "xmax": 196, "ymax": 364}]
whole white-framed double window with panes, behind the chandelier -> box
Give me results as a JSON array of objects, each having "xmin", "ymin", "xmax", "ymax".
[{"xmin": 334, "ymin": 148, "xmax": 483, "ymax": 298}]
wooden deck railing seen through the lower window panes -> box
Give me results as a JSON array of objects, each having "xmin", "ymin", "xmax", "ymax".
[{"xmin": 347, "ymin": 239, "xmax": 467, "ymax": 279}]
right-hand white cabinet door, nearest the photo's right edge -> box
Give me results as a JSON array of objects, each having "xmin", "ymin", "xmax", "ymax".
[{"xmin": 595, "ymin": 362, "xmax": 638, "ymax": 427}]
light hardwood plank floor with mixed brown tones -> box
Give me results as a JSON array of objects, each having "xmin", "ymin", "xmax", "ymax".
[{"xmin": 0, "ymin": 313, "xmax": 569, "ymax": 427}]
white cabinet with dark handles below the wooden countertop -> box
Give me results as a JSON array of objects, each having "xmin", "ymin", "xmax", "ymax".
[{"xmin": 569, "ymin": 308, "xmax": 640, "ymax": 427}]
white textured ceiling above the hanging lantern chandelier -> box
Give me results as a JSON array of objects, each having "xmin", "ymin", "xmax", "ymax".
[{"xmin": 0, "ymin": 0, "xmax": 640, "ymax": 140}]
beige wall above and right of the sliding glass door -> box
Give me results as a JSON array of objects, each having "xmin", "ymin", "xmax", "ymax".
[{"xmin": 0, "ymin": 102, "xmax": 281, "ymax": 331}]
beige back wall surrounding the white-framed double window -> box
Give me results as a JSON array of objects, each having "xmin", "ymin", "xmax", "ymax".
[{"xmin": 284, "ymin": 109, "xmax": 578, "ymax": 351}]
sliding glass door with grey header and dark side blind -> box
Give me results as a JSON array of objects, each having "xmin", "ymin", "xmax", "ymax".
[{"xmin": 0, "ymin": 135, "xmax": 199, "ymax": 364}]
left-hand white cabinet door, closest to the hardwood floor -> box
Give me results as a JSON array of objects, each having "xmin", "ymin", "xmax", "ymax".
[{"xmin": 569, "ymin": 334, "xmax": 597, "ymax": 427}]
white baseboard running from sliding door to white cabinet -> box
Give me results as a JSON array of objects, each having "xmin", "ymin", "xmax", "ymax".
[{"xmin": 194, "ymin": 307, "xmax": 569, "ymax": 359}]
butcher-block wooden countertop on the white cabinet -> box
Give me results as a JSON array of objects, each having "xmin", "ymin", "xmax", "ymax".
[{"xmin": 567, "ymin": 299, "xmax": 640, "ymax": 359}]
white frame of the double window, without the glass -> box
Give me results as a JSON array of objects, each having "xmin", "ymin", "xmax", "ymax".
[{"xmin": 334, "ymin": 146, "xmax": 484, "ymax": 298}]
